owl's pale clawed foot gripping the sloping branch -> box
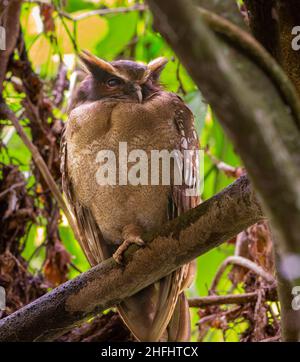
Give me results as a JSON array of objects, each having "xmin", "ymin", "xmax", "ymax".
[{"xmin": 113, "ymin": 224, "xmax": 145, "ymax": 264}]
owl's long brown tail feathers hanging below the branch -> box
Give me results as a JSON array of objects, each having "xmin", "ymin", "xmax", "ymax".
[{"xmin": 118, "ymin": 265, "xmax": 190, "ymax": 342}]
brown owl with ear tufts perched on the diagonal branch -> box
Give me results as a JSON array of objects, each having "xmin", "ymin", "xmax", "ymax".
[{"xmin": 61, "ymin": 52, "xmax": 200, "ymax": 341}]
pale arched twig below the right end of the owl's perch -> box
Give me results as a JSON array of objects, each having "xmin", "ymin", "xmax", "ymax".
[{"xmin": 211, "ymin": 256, "xmax": 276, "ymax": 291}]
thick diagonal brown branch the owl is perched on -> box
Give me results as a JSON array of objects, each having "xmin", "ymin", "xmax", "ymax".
[{"xmin": 0, "ymin": 176, "xmax": 263, "ymax": 341}]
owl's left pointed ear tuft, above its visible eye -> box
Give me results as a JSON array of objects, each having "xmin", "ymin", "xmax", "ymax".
[{"xmin": 79, "ymin": 50, "xmax": 117, "ymax": 76}]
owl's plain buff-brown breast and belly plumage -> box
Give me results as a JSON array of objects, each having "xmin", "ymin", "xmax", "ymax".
[{"xmin": 68, "ymin": 94, "xmax": 180, "ymax": 238}]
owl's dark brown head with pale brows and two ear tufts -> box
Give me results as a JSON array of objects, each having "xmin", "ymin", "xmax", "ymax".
[{"xmin": 72, "ymin": 51, "xmax": 167, "ymax": 104}]
